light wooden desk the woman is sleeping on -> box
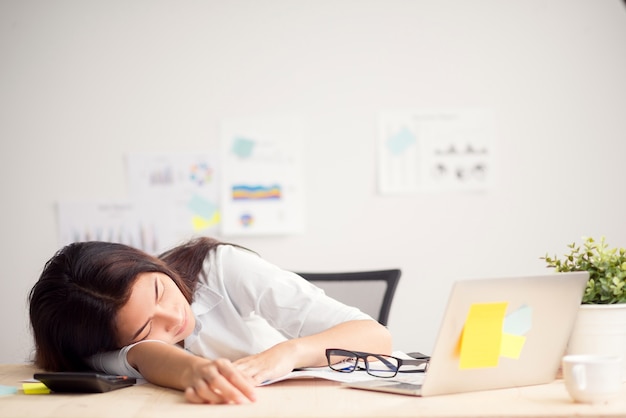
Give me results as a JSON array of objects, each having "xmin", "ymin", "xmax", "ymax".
[{"xmin": 0, "ymin": 365, "xmax": 626, "ymax": 418}]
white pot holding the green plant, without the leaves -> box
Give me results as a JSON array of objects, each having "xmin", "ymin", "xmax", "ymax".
[{"xmin": 567, "ymin": 303, "xmax": 626, "ymax": 381}]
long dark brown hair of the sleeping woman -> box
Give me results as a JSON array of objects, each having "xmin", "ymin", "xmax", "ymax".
[{"xmin": 28, "ymin": 238, "xmax": 221, "ymax": 371}]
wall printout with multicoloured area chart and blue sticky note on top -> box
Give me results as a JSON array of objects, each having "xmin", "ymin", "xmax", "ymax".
[{"xmin": 220, "ymin": 117, "xmax": 304, "ymax": 236}]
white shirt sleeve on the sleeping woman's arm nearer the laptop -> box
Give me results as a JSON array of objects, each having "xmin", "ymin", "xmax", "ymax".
[{"xmin": 217, "ymin": 246, "xmax": 372, "ymax": 338}]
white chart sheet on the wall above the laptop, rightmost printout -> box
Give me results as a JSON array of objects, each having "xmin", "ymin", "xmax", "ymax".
[{"xmin": 377, "ymin": 109, "xmax": 496, "ymax": 194}]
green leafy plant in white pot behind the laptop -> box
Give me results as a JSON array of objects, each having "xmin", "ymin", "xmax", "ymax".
[{"xmin": 541, "ymin": 237, "xmax": 626, "ymax": 379}]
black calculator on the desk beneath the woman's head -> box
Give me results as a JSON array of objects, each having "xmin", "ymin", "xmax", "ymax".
[{"xmin": 33, "ymin": 372, "xmax": 137, "ymax": 393}]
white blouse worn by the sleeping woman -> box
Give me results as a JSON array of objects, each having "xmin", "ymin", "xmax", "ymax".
[{"xmin": 89, "ymin": 245, "xmax": 372, "ymax": 377}]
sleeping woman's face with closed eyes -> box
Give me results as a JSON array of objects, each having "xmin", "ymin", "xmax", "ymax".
[{"xmin": 116, "ymin": 272, "xmax": 196, "ymax": 346}]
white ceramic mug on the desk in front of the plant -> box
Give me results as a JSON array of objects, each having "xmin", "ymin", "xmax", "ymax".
[{"xmin": 562, "ymin": 354, "xmax": 622, "ymax": 403}]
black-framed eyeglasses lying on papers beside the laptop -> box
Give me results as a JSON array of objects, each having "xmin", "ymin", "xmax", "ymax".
[{"xmin": 326, "ymin": 348, "xmax": 430, "ymax": 377}]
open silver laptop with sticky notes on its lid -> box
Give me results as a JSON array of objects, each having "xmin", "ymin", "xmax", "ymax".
[{"xmin": 343, "ymin": 272, "xmax": 589, "ymax": 396}]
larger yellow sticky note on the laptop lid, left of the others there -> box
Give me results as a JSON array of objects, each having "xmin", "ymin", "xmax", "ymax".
[{"xmin": 459, "ymin": 302, "xmax": 507, "ymax": 369}]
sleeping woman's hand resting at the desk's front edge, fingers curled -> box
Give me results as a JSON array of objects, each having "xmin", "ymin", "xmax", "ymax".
[{"xmin": 185, "ymin": 359, "xmax": 255, "ymax": 404}]
